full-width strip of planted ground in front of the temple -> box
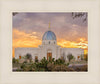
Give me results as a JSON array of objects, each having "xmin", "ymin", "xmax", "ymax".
[{"xmin": 13, "ymin": 58, "xmax": 88, "ymax": 72}]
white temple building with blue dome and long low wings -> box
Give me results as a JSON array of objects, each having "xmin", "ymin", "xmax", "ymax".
[{"xmin": 15, "ymin": 23, "xmax": 84, "ymax": 61}]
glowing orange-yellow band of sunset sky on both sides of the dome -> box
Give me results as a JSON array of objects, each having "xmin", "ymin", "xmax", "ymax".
[{"xmin": 12, "ymin": 28, "xmax": 88, "ymax": 57}]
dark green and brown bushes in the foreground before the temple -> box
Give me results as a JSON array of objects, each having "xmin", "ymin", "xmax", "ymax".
[{"xmin": 13, "ymin": 57, "xmax": 87, "ymax": 71}]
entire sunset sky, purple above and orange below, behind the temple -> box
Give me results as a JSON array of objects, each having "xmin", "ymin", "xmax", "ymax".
[{"xmin": 12, "ymin": 12, "xmax": 88, "ymax": 57}]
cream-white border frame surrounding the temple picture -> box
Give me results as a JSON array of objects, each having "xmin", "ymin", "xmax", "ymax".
[{"xmin": 0, "ymin": 0, "xmax": 100, "ymax": 84}]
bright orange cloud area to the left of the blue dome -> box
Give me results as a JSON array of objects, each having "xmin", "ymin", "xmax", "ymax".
[{"xmin": 13, "ymin": 29, "xmax": 41, "ymax": 47}]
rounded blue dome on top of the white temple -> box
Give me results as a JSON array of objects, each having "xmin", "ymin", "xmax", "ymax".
[{"xmin": 42, "ymin": 30, "xmax": 56, "ymax": 40}]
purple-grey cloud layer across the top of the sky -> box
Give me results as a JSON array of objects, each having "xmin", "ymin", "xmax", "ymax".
[{"xmin": 13, "ymin": 13, "xmax": 87, "ymax": 32}]
